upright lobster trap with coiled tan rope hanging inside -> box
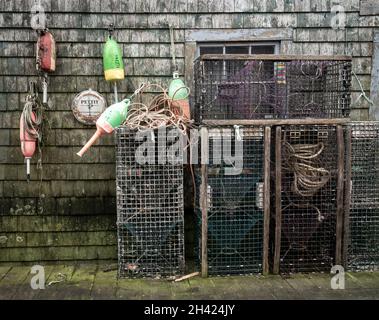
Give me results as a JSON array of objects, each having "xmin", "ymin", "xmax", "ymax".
[{"xmin": 273, "ymin": 125, "xmax": 345, "ymax": 273}]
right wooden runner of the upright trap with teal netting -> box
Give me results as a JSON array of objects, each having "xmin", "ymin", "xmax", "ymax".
[{"xmin": 263, "ymin": 127, "xmax": 271, "ymax": 274}]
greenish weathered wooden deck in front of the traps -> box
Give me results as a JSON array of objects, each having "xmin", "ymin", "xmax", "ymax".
[{"xmin": 0, "ymin": 263, "xmax": 379, "ymax": 300}]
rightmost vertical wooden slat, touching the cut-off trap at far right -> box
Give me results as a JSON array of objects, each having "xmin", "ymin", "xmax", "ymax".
[{"xmin": 342, "ymin": 126, "xmax": 352, "ymax": 270}]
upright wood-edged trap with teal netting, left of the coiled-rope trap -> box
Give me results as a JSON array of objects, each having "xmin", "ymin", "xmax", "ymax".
[{"xmin": 196, "ymin": 126, "xmax": 270, "ymax": 276}]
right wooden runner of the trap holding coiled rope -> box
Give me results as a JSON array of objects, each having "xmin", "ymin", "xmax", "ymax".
[{"xmin": 336, "ymin": 125, "xmax": 345, "ymax": 265}]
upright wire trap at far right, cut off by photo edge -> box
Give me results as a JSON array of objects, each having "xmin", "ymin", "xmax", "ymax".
[{"xmin": 347, "ymin": 122, "xmax": 379, "ymax": 271}]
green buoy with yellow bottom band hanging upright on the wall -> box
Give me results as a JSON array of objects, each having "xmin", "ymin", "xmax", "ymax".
[{"xmin": 103, "ymin": 24, "xmax": 125, "ymax": 102}]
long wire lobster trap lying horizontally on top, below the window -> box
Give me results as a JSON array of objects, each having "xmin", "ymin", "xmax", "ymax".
[{"xmin": 194, "ymin": 54, "xmax": 351, "ymax": 123}]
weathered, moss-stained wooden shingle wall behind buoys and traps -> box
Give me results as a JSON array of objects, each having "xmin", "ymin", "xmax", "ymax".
[{"xmin": 0, "ymin": 0, "xmax": 379, "ymax": 261}]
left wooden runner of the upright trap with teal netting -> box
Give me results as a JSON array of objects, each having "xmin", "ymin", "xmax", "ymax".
[{"xmin": 200, "ymin": 128, "xmax": 209, "ymax": 277}]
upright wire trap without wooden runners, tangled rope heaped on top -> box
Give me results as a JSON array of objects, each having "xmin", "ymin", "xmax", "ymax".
[{"xmin": 116, "ymin": 127, "xmax": 184, "ymax": 277}]
